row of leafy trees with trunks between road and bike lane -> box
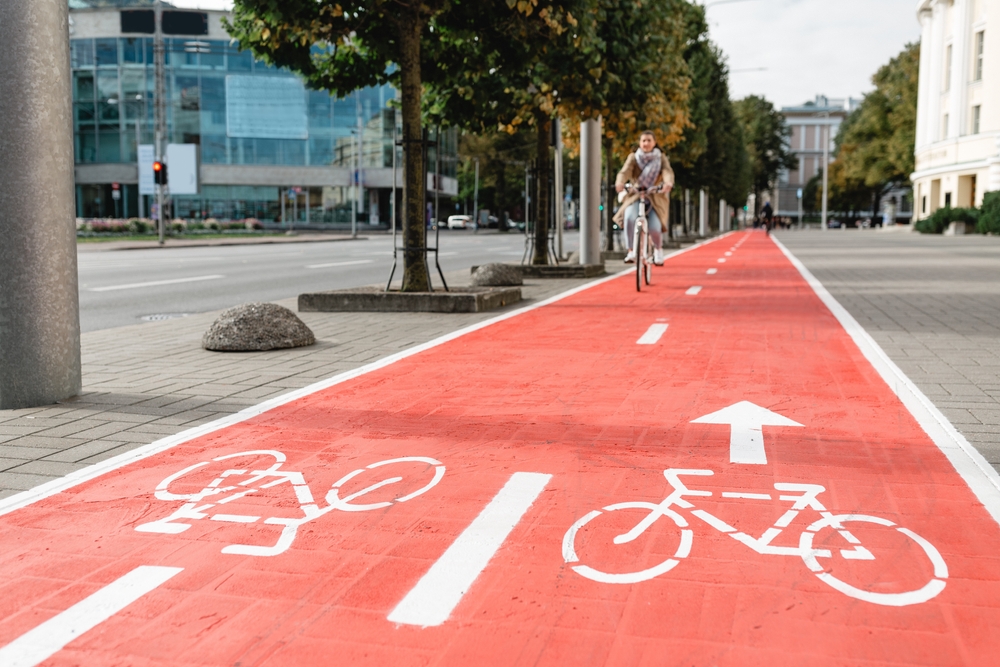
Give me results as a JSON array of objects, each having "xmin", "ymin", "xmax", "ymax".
[{"xmin": 227, "ymin": 0, "xmax": 787, "ymax": 291}]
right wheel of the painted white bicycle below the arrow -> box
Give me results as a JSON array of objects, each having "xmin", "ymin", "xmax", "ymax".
[{"xmin": 799, "ymin": 514, "xmax": 948, "ymax": 607}]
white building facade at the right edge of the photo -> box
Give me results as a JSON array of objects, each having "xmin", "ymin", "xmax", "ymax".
[{"xmin": 911, "ymin": 0, "xmax": 1000, "ymax": 219}]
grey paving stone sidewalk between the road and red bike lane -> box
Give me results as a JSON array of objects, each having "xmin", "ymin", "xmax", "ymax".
[{"xmin": 0, "ymin": 264, "xmax": 624, "ymax": 498}]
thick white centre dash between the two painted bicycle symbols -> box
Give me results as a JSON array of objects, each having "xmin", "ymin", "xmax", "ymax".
[{"xmin": 387, "ymin": 472, "xmax": 552, "ymax": 628}]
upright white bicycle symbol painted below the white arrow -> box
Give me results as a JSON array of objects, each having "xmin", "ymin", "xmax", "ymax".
[{"xmin": 562, "ymin": 469, "xmax": 948, "ymax": 607}]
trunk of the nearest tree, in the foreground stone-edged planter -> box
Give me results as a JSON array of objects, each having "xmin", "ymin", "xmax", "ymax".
[{"xmin": 399, "ymin": 15, "xmax": 431, "ymax": 292}]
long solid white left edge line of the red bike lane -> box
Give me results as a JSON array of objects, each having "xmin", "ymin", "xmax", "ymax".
[{"xmin": 0, "ymin": 232, "xmax": 738, "ymax": 516}]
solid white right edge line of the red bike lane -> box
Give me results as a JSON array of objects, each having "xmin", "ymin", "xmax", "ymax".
[{"xmin": 771, "ymin": 236, "xmax": 1000, "ymax": 523}]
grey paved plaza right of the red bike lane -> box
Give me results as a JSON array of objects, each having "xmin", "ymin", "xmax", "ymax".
[{"xmin": 777, "ymin": 230, "xmax": 1000, "ymax": 470}]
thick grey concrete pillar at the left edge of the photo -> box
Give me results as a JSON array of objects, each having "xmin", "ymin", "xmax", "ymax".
[{"xmin": 0, "ymin": 2, "xmax": 81, "ymax": 409}]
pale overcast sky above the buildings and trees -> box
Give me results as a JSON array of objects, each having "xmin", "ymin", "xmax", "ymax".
[{"xmin": 178, "ymin": 0, "xmax": 920, "ymax": 107}]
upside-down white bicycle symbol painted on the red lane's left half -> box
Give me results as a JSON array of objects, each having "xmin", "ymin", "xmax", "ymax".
[{"xmin": 135, "ymin": 450, "xmax": 445, "ymax": 556}]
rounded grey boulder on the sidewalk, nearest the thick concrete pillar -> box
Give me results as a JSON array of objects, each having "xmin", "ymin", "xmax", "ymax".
[{"xmin": 201, "ymin": 303, "xmax": 316, "ymax": 352}]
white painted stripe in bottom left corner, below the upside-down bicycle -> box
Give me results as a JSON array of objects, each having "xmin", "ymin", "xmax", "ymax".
[{"xmin": 0, "ymin": 565, "xmax": 184, "ymax": 667}]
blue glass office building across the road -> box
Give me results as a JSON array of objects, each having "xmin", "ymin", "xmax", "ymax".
[{"xmin": 70, "ymin": 4, "xmax": 457, "ymax": 226}]
